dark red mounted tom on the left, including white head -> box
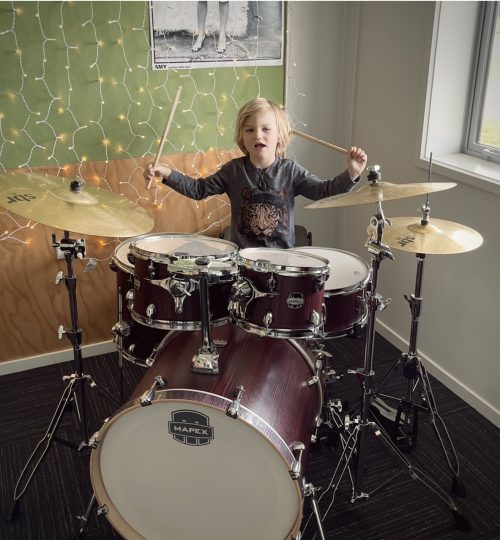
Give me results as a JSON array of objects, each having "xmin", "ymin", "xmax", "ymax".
[{"xmin": 130, "ymin": 233, "xmax": 238, "ymax": 330}]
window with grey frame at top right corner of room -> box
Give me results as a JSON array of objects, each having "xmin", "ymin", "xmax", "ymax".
[{"xmin": 464, "ymin": 2, "xmax": 500, "ymax": 163}]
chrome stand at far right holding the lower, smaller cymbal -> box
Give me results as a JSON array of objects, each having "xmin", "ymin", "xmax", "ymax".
[{"xmin": 373, "ymin": 201, "xmax": 465, "ymax": 497}]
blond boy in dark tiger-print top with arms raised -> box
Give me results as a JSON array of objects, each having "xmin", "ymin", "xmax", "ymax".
[{"xmin": 146, "ymin": 98, "xmax": 367, "ymax": 248}]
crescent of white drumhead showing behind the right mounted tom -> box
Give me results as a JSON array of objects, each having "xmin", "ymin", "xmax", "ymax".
[{"xmin": 294, "ymin": 246, "xmax": 370, "ymax": 292}]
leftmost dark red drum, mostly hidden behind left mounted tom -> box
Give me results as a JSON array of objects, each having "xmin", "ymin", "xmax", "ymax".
[{"xmin": 110, "ymin": 235, "xmax": 168, "ymax": 367}]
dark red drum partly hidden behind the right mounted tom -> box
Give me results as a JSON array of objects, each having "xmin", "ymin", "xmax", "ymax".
[{"xmin": 296, "ymin": 246, "xmax": 370, "ymax": 338}]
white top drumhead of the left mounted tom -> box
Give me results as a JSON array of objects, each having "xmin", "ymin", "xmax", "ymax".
[{"xmin": 131, "ymin": 233, "xmax": 238, "ymax": 259}]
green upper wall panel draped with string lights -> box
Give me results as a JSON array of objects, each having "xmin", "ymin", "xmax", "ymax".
[{"xmin": 0, "ymin": 1, "xmax": 283, "ymax": 169}]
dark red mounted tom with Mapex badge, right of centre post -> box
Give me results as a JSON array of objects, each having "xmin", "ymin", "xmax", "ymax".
[{"xmin": 229, "ymin": 248, "xmax": 329, "ymax": 338}]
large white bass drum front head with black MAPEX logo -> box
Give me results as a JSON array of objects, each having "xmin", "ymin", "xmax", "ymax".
[{"xmin": 91, "ymin": 399, "xmax": 302, "ymax": 540}]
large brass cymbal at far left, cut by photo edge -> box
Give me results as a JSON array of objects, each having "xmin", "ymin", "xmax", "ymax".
[{"xmin": 0, "ymin": 172, "xmax": 154, "ymax": 237}]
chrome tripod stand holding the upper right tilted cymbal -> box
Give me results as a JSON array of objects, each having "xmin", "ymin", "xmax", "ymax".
[{"xmin": 306, "ymin": 195, "xmax": 470, "ymax": 530}]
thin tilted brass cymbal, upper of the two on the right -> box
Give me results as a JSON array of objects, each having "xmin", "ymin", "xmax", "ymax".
[{"xmin": 304, "ymin": 182, "xmax": 457, "ymax": 208}]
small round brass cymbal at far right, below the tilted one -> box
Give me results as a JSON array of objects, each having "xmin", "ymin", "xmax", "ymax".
[{"xmin": 368, "ymin": 217, "xmax": 483, "ymax": 255}]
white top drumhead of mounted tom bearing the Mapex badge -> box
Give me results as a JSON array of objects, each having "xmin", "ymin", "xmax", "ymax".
[{"xmin": 238, "ymin": 248, "xmax": 328, "ymax": 270}]
